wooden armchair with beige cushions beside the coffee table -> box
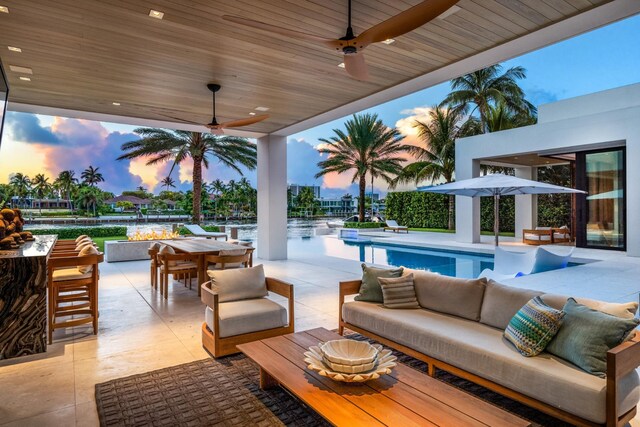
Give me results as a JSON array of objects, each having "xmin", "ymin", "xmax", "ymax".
[{"xmin": 201, "ymin": 265, "xmax": 294, "ymax": 357}]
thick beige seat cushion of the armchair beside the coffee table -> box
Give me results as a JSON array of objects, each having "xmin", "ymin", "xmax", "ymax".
[{"xmin": 204, "ymin": 298, "xmax": 287, "ymax": 338}]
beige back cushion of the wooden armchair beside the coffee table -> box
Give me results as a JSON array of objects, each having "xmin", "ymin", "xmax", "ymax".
[{"xmin": 207, "ymin": 264, "xmax": 268, "ymax": 302}]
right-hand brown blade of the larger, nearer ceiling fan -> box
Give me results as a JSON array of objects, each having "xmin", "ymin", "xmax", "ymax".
[{"xmin": 356, "ymin": 0, "xmax": 459, "ymax": 46}]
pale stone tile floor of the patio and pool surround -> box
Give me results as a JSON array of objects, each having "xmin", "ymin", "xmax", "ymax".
[{"xmin": 0, "ymin": 232, "xmax": 640, "ymax": 426}]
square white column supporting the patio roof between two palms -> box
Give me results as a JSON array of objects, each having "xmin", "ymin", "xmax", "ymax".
[{"xmin": 257, "ymin": 135, "xmax": 287, "ymax": 260}]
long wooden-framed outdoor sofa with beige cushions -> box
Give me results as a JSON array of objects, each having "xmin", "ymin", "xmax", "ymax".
[{"xmin": 338, "ymin": 269, "xmax": 640, "ymax": 426}]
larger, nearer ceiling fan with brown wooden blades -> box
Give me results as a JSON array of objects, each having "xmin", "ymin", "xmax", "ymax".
[{"xmin": 222, "ymin": 0, "xmax": 459, "ymax": 80}]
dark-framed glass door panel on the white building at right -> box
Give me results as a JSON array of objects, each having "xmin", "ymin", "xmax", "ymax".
[{"xmin": 585, "ymin": 150, "xmax": 625, "ymax": 249}]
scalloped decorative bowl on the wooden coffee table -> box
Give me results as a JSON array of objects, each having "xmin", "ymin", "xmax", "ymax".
[{"xmin": 304, "ymin": 341, "xmax": 396, "ymax": 383}]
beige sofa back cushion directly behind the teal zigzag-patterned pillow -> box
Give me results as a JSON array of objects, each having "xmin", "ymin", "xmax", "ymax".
[{"xmin": 480, "ymin": 279, "xmax": 544, "ymax": 330}]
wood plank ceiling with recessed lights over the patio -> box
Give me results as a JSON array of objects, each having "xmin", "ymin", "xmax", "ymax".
[{"xmin": 0, "ymin": 0, "xmax": 609, "ymax": 133}]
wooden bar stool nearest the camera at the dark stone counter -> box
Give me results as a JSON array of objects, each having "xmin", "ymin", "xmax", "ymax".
[{"xmin": 47, "ymin": 246, "xmax": 104, "ymax": 344}]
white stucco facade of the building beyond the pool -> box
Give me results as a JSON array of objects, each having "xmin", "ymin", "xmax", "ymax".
[{"xmin": 456, "ymin": 84, "xmax": 640, "ymax": 256}]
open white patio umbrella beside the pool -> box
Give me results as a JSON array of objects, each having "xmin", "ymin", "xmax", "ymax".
[{"xmin": 418, "ymin": 173, "xmax": 586, "ymax": 246}]
